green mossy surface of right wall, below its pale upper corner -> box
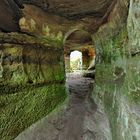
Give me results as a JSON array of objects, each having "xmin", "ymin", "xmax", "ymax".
[{"xmin": 93, "ymin": 26, "xmax": 140, "ymax": 140}]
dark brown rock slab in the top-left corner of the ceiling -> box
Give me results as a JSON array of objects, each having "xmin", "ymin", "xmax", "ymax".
[{"xmin": 0, "ymin": 0, "xmax": 23, "ymax": 32}]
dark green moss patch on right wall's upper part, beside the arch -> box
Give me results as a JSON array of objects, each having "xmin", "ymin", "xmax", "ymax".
[{"xmin": 94, "ymin": 28, "xmax": 128, "ymax": 64}]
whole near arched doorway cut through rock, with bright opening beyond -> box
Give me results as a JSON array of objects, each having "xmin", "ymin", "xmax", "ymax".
[{"xmin": 64, "ymin": 29, "xmax": 95, "ymax": 73}]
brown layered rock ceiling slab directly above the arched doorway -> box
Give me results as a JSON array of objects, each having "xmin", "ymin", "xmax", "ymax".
[{"xmin": 24, "ymin": 0, "xmax": 117, "ymax": 33}]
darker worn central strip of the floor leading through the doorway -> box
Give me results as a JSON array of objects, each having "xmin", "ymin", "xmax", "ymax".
[{"xmin": 59, "ymin": 74, "xmax": 93, "ymax": 140}]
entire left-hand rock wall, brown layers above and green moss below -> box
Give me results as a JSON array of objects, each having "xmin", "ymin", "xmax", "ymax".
[{"xmin": 0, "ymin": 33, "xmax": 66, "ymax": 140}]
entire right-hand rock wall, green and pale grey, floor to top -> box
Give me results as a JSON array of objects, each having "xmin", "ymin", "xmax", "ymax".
[{"xmin": 93, "ymin": 0, "xmax": 140, "ymax": 140}]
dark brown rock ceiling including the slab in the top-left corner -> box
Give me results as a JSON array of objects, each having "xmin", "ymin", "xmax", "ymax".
[{"xmin": 0, "ymin": 0, "xmax": 116, "ymax": 32}]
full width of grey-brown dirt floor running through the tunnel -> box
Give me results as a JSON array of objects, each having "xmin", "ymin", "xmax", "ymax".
[{"xmin": 15, "ymin": 74, "xmax": 110, "ymax": 140}]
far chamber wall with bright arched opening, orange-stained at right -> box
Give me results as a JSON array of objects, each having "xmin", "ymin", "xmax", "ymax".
[{"xmin": 64, "ymin": 46, "xmax": 95, "ymax": 73}]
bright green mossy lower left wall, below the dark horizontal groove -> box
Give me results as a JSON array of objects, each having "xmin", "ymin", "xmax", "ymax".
[{"xmin": 0, "ymin": 84, "xmax": 66, "ymax": 140}]
